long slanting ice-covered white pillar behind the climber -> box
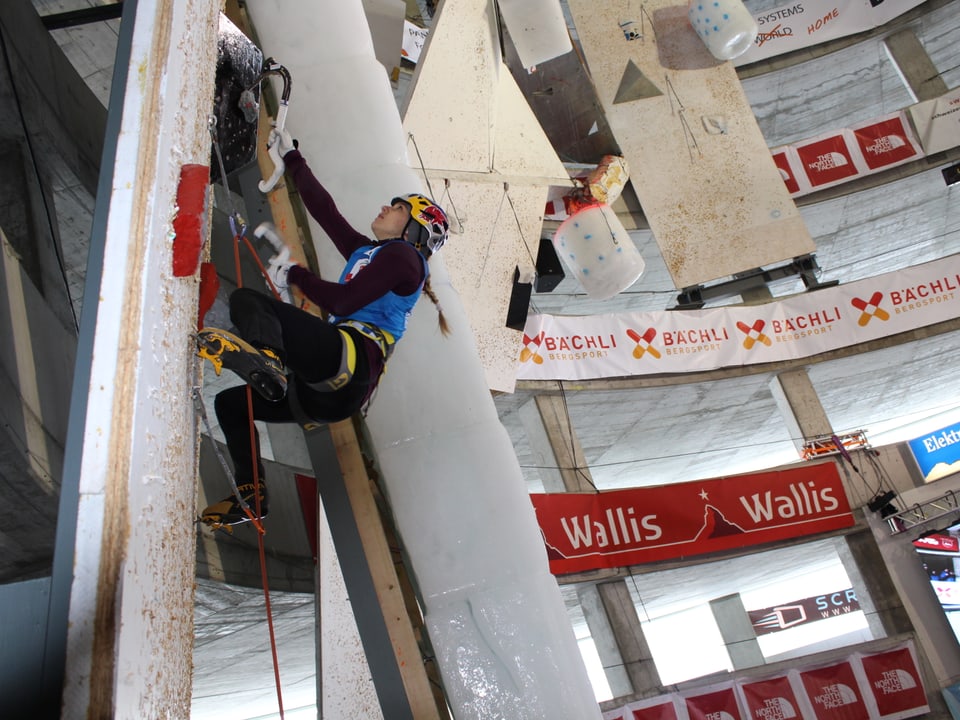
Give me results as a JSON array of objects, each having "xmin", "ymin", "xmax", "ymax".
[{"xmin": 248, "ymin": 0, "xmax": 600, "ymax": 720}]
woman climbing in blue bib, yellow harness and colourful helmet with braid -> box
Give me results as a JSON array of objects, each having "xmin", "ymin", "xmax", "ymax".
[{"xmin": 198, "ymin": 130, "xmax": 449, "ymax": 527}]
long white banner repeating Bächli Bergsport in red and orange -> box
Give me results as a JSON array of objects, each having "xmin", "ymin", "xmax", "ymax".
[{"xmin": 517, "ymin": 255, "xmax": 960, "ymax": 380}]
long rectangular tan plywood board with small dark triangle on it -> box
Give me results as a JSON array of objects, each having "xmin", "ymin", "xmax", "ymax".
[{"xmin": 570, "ymin": 0, "xmax": 815, "ymax": 288}]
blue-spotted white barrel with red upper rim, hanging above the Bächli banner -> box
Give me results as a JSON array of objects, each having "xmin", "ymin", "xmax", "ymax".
[{"xmin": 553, "ymin": 204, "xmax": 645, "ymax": 300}]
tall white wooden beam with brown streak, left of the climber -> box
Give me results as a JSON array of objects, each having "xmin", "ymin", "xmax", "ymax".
[{"xmin": 63, "ymin": 0, "xmax": 219, "ymax": 717}]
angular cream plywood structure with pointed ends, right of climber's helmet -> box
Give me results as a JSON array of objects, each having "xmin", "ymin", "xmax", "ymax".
[{"xmin": 403, "ymin": 0, "xmax": 571, "ymax": 392}]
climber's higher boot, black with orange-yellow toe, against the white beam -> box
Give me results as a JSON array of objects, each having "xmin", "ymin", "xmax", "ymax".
[{"xmin": 197, "ymin": 328, "xmax": 287, "ymax": 402}]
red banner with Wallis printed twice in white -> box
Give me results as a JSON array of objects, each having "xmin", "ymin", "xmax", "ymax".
[{"xmin": 530, "ymin": 462, "xmax": 854, "ymax": 575}]
